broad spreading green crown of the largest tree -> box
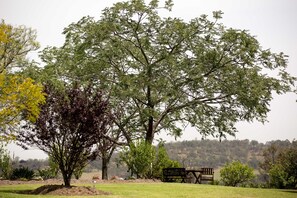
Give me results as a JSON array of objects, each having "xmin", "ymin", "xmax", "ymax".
[{"xmin": 38, "ymin": 0, "xmax": 295, "ymax": 143}]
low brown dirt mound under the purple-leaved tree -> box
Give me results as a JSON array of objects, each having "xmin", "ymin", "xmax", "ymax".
[{"xmin": 23, "ymin": 185, "xmax": 110, "ymax": 196}]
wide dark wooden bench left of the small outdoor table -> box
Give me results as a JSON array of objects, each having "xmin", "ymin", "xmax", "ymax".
[{"xmin": 163, "ymin": 168, "xmax": 187, "ymax": 183}]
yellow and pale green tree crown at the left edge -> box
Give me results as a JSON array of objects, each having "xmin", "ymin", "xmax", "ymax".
[{"xmin": 0, "ymin": 21, "xmax": 45, "ymax": 140}]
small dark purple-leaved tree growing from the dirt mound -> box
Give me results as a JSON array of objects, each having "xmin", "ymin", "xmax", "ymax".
[{"xmin": 18, "ymin": 85, "xmax": 113, "ymax": 187}]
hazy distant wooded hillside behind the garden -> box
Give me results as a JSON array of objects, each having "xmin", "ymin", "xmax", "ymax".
[{"xmin": 13, "ymin": 140, "xmax": 291, "ymax": 177}]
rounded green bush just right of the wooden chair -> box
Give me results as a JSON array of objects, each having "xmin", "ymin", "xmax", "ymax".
[{"xmin": 220, "ymin": 161, "xmax": 255, "ymax": 186}]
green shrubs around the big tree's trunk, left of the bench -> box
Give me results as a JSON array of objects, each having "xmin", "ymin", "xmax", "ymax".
[{"xmin": 120, "ymin": 140, "xmax": 179, "ymax": 178}]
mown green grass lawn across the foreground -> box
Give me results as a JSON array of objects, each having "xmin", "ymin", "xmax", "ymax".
[{"xmin": 0, "ymin": 183, "xmax": 297, "ymax": 198}]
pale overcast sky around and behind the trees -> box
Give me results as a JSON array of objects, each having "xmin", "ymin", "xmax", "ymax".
[{"xmin": 0, "ymin": 0, "xmax": 297, "ymax": 159}]
